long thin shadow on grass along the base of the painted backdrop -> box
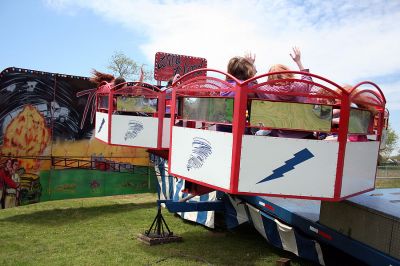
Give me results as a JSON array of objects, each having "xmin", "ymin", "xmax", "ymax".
[{"xmin": 0, "ymin": 202, "xmax": 156, "ymax": 226}]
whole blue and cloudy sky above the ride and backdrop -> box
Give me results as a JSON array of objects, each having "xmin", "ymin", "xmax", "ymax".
[{"xmin": 0, "ymin": 0, "xmax": 400, "ymax": 140}]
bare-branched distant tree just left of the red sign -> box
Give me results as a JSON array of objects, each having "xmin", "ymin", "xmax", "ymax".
[{"xmin": 107, "ymin": 52, "xmax": 154, "ymax": 82}]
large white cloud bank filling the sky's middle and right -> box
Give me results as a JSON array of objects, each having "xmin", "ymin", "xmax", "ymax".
[{"xmin": 46, "ymin": 0, "xmax": 400, "ymax": 108}]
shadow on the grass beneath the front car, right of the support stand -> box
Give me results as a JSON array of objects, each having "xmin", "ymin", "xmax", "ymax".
[{"xmin": 140, "ymin": 224, "xmax": 315, "ymax": 265}]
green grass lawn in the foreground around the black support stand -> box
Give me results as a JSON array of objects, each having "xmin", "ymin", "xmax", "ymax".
[{"xmin": 0, "ymin": 194, "xmax": 311, "ymax": 265}]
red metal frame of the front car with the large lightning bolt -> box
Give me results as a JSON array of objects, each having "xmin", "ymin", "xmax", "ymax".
[{"xmin": 168, "ymin": 69, "xmax": 386, "ymax": 201}]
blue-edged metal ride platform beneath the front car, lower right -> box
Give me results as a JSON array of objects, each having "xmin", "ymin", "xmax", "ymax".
[{"xmin": 239, "ymin": 188, "xmax": 400, "ymax": 265}]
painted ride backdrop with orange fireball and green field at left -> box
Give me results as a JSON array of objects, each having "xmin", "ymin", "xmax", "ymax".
[{"xmin": 0, "ymin": 68, "xmax": 155, "ymax": 204}]
